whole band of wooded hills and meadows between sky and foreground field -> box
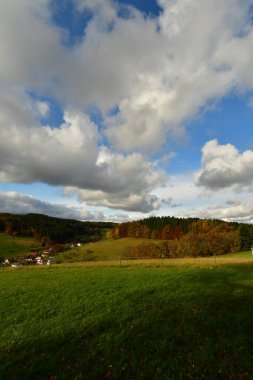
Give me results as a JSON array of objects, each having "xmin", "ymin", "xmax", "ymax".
[{"xmin": 0, "ymin": 214, "xmax": 253, "ymax": 263}]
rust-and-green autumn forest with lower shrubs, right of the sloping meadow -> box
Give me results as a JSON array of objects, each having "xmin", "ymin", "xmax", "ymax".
[{"xmin": 109, "ymin": 216, "xmax": 253, "ymax": 257}]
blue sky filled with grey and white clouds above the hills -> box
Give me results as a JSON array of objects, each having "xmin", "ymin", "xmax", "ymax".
[{"xmin": 0, "ymin": 0, "xmax": 253, "ymax": 223}]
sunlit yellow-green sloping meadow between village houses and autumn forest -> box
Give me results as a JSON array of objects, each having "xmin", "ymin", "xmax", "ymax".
[{"xmin": 57, "ymin": 238, "xmax": 161, "ymax": 262}]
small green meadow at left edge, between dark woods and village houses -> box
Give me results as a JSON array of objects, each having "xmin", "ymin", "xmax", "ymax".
[{"xmin": 0, "ymin": 233, "xmax": 40, "ymax": 259}]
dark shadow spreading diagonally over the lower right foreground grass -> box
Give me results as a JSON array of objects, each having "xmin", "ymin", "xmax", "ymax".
[{"xmin": 0, "ymin": 266, "xmax": 253, "ymax": 380}]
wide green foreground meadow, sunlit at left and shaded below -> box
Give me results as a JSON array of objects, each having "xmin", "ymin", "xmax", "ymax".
[{"xmin": 0, "ymin": 263, "xmax": 253, "ymax": 380}]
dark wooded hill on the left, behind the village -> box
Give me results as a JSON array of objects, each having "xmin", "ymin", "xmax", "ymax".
[{"xmin": 0, "ymin": 213, "xmax": 115, "ymax": 243}]
